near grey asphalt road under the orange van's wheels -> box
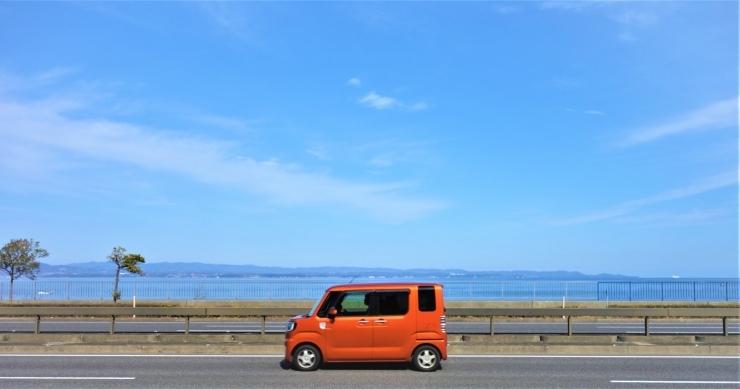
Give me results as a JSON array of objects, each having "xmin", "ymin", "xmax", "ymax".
[{"xmin": 0, "ymin": 355, "xmax": 740, "ymax": 389}]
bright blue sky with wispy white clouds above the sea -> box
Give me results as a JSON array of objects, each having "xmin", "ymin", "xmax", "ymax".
[{"xmin": 0, "ymin": 1, "xmax": 738, "ymax": 277}]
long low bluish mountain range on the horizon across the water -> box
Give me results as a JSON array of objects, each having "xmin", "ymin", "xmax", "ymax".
[{"xmin": 39, "ymin": 262, "xmax": 638, "ymax": 280}]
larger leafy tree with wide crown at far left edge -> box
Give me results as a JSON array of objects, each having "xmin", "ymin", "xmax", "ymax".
[{"xmin": 0, "ymin": 239, "xmax": 49, "ymax": 301}]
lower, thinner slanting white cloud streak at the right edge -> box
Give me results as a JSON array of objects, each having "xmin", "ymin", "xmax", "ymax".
[{"xmin": 557, "ymin": 171, "xmax": 738, "ymax": 225}]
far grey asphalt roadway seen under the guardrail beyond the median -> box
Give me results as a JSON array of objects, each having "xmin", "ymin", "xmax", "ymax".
[{"xmin": 0, "ymin": 318, "xmax": 740, "ymax": 335}]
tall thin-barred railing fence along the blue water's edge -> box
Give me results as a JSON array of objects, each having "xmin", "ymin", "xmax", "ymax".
[{"xmin": 0, "ymin": 278, "xmax": 740, "ymax": 302}]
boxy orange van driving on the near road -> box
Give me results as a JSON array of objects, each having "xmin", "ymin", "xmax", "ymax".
[{"xmin": 285, "ymin": 283, "xmax": 447, "ymax": 371}]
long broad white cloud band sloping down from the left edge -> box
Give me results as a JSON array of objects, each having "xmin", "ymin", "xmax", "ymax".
[{"xmin": 0, "ymin": 95, "xmax": 445, "ymax": 222}]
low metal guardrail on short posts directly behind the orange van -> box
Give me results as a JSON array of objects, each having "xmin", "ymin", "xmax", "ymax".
[{"xmin": 0, "ymin": 307, "xmax": 740, "ymax": 336}]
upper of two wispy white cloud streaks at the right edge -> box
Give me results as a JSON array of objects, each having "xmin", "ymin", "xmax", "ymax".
[{"xmin": 619, "ymin": 98, "xmax": 738, "ymax": 146}]
